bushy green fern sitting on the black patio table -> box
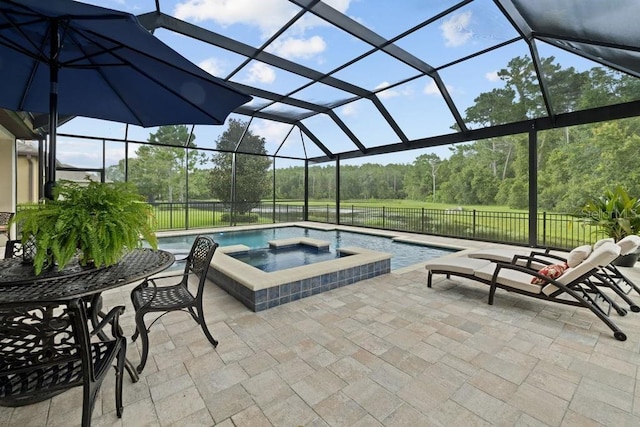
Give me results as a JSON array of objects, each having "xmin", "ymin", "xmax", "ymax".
[{"xmin": 12, "ymin": 181, "xmax": 158, "ymax": 274}]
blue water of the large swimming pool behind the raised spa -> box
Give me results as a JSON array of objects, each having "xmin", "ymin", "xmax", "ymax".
[{"xmin": 158, "ymin": 226, "xmax": 456, "ymax": 270}]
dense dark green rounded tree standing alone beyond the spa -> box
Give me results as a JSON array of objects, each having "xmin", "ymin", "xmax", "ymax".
[{"xmin": 210, "ymin": 119, "xmax": 271, "ymax": 214}]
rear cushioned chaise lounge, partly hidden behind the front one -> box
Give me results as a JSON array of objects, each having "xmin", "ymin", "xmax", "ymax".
[{"xmin": 467, "ymin": 235, "xmax": 640, "ymax": 313}]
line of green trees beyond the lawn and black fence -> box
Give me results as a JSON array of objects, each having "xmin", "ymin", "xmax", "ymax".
[{"xmin": 107, "ymin": 57, "xmax": 640, "ymax": 212}]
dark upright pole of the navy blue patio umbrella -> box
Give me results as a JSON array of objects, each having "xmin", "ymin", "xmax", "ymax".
[{"xmin": 44, "ymin": 19, "xmax": 60, "ymax": 200}]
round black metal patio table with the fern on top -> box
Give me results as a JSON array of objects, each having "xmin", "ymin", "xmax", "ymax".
[{"xmin": 0, "ymin": 248, "xmax": 175, "ymax": 382}]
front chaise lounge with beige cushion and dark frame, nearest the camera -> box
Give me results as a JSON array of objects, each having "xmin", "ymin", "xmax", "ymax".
[{"xmin": 425, "ymin": 242, "xmax": 627, "ymax": 341}]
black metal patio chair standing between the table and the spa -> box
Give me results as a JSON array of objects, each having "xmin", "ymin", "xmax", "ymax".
[{"xmin": 131, "ymin": 236, "xmax": 218, "ymax": 373}]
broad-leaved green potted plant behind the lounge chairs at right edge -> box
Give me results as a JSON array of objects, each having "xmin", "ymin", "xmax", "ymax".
[{"xmin": 582, "ymin": 185, "xmax": 640, "ymax": 266}]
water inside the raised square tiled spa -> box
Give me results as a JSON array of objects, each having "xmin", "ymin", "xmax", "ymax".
[{"xmin": 229, "ymin": 245, "xmax": 348, "ymax": 272}]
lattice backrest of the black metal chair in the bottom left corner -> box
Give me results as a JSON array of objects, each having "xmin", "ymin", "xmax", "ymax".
[{"xmin": 0, "ymin": 300, "xmax": 91, "ymax": 406}]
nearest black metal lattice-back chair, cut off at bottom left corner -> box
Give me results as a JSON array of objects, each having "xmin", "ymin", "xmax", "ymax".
[{"xmin": 0, "ymin": 298, "xmax": 126, "ymax": 427}]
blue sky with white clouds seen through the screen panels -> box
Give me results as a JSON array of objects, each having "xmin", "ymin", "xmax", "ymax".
[{"xmin": 52, "ymin": 0, "xmax": 608, "ymax": 171}]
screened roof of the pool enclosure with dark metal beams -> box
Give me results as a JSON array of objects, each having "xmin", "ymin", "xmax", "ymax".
[{"xmin": 27, "ymin": 0, "xmax": 640, "ymax": 162}]
